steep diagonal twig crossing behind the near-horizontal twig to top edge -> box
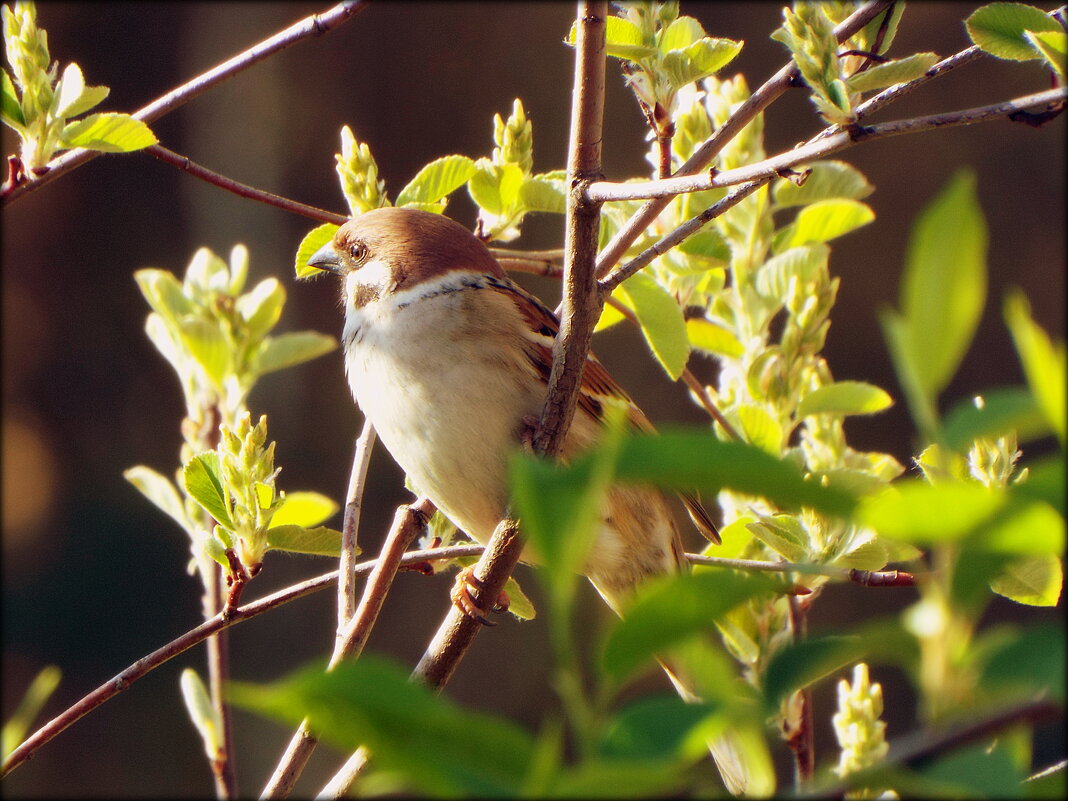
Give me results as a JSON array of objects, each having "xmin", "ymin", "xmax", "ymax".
[{"xmin": 597, "ymin": 0, "xmax": 893, "ymax": 278}]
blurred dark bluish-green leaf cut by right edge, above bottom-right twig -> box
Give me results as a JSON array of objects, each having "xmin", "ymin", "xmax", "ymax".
[{"xmin": 979, "ymin": 625, "xmax": 1065, "ymax": 703}]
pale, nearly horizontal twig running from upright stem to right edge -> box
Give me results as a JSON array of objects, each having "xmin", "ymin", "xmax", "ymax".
[{"xmin": 587, "ymin": 89, "xmax": 1068, "ymax": 202}]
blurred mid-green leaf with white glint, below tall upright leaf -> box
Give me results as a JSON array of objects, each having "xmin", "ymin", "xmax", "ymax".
[{"xmin": 943, "ymin": 387, "xmax": 1050, "ymax": 453}]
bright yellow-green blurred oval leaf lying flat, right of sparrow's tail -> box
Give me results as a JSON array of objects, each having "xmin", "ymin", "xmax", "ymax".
[{"xmin": 855, "ymin": 478, "xmax": 1007, "ymax": 545}]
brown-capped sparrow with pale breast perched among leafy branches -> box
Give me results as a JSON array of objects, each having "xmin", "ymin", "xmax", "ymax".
[{"xmin": 308, "ymin": 207, "xmax": 745, "ymax": 795}]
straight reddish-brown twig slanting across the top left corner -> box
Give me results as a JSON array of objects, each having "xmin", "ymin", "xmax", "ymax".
[{"xmin": 2, "ymin": 0, "xmax": 367, "ymax": 205}]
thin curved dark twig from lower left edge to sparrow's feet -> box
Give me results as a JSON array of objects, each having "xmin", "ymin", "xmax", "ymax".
[{"xmin": 0, "ymin": 545, "xmax": 484, "ymax": 776}]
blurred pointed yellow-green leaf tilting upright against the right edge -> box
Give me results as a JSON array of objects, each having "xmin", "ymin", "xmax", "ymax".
[{"xmin": 1004, "ymin": 289, "xmax": 1068, "ymax": 446}]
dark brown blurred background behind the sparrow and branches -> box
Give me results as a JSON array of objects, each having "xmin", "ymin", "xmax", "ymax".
[{"xmin": 2, "ymin": 2, "xmax": 1065, "ymax": 797}]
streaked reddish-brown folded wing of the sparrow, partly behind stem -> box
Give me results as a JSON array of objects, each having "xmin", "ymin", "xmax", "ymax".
[{"xmin": 492, "ymin": 281, "xmax": 721, "ymax": 545}]
